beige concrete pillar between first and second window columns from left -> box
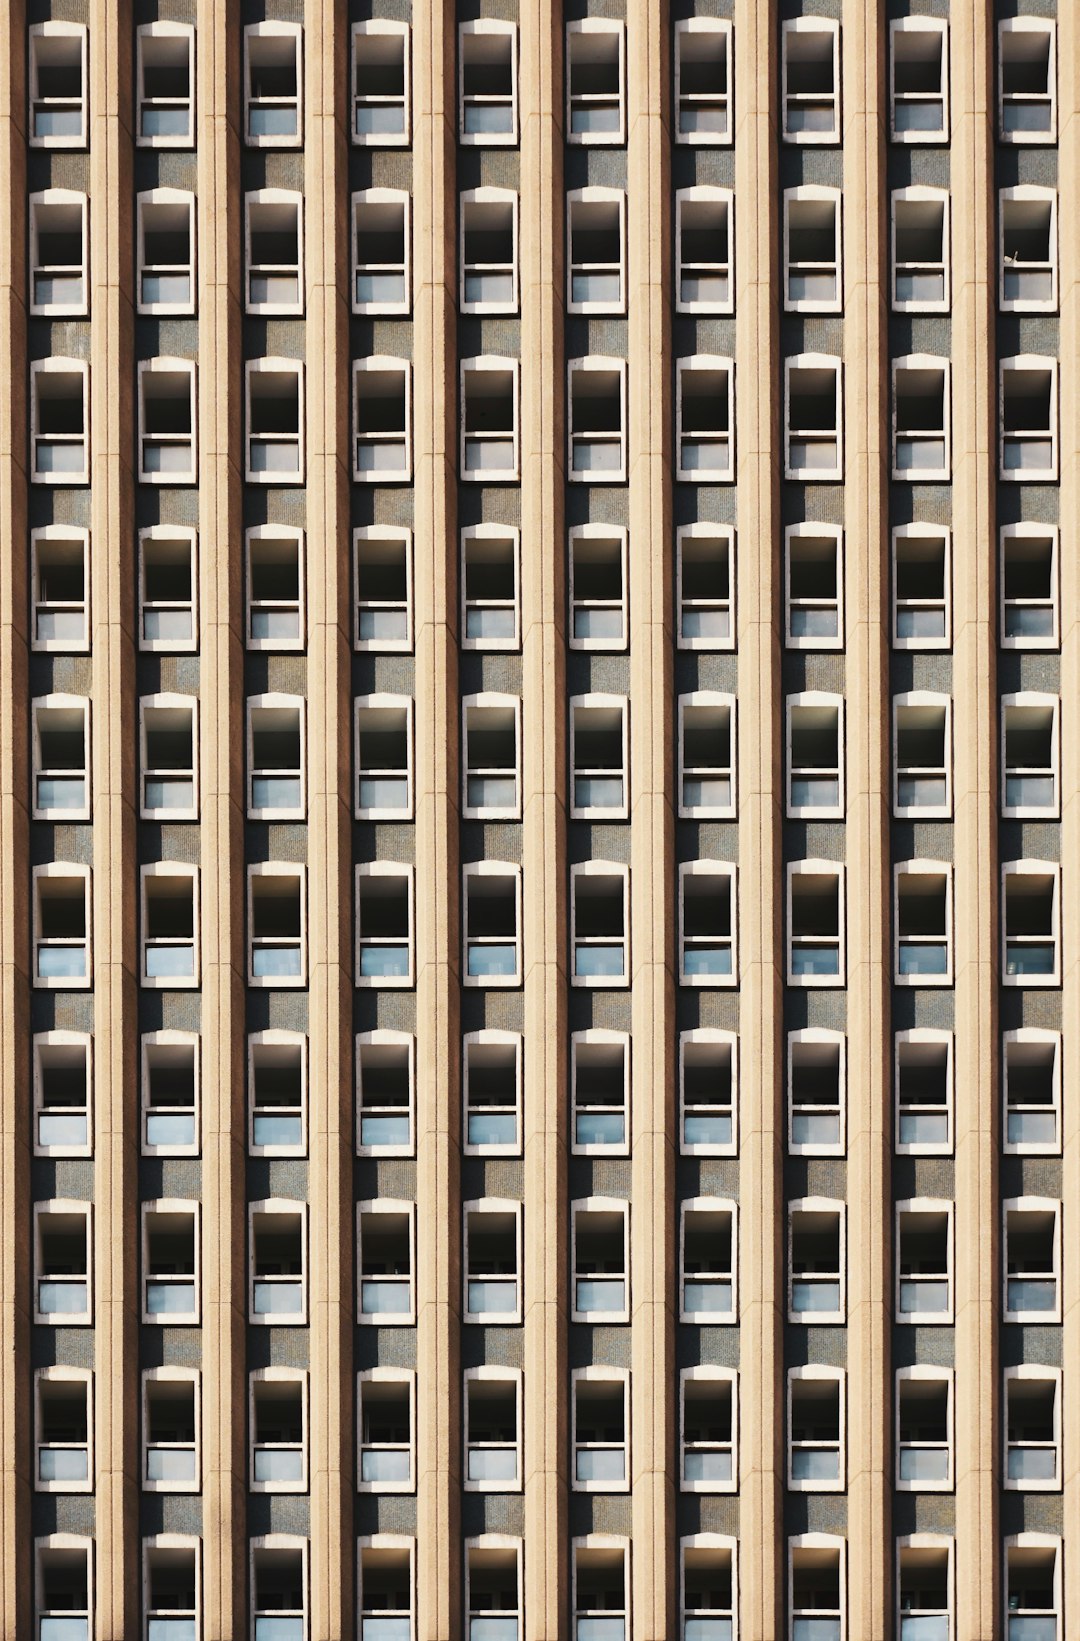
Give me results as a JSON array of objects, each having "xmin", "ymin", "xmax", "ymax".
[{"xmin": 89, "ymin": 0, "xmax": 140, "ymax": 1641}]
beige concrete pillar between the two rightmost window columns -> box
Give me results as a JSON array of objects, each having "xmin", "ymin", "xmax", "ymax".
[{"xmin": 952, "ymin": 9, "xmax": 1001, "ymax": 1641}]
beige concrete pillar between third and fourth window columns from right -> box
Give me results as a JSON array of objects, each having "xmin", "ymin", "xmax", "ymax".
[{"xmin": 734, "ymin": 0, "xmax": 783, "ymax": 1641}]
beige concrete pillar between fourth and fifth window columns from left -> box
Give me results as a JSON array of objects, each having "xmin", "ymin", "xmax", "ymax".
[{"xmin": 414, "ymin": 0, "xmax": 461, "ymax": 1641}]
